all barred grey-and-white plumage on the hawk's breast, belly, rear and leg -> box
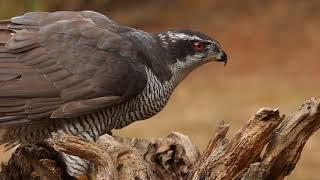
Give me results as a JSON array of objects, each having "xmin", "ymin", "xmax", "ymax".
[{"xmin": 0, "ymin": 69, "xmax": 176, "ymax": 176}]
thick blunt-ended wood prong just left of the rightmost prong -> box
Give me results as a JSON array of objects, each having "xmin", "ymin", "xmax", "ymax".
[{"xmin": 189, "ymin": 108, "xmax": 283, "ymax": 180}]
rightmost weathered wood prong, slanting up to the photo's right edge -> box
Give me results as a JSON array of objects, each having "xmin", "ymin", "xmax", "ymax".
[{"xmin": 241, "ymin": 98, "xmax": 320, "ymax": 180}]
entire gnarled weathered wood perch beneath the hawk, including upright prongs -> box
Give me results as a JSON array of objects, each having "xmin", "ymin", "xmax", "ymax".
[{"xmin": 0, "ymin": 98, "xmax": 320, "ymax": 180}]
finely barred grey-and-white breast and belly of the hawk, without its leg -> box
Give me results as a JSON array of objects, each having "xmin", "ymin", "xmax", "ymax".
[{"xmin": 60, "ymin": 68, "xmax": 175, "ymax": 139}]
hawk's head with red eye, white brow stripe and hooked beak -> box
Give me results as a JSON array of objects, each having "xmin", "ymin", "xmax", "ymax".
[{"xmin": 157, "ymin": 30, "xmax": 227, "ymax": 83}]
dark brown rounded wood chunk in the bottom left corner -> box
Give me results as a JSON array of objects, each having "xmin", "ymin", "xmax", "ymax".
[{"xmin": 0, "ymin": 143, "xmax": 72, "ymax": 180}]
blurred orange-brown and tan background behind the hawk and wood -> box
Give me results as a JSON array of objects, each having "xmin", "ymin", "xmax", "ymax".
[{"xmin": 0, "ymin": 0, "xmax": 320, "ymax": 179}]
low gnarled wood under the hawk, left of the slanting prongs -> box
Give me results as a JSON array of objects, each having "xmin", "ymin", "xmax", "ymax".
[{"xmin": 0, "ymin": 132, "xmax": 200, "ymax": 180}]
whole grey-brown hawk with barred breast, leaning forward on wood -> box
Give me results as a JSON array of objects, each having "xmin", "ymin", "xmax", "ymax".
[{"xmin": 0, "ymin": 11, "xmax": 227, "ymax": 176}]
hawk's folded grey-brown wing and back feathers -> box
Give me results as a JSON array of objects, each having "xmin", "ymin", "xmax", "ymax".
[{"xmin": 0, "ymin": 11, "xmax": 147, "ymax": 127}]
